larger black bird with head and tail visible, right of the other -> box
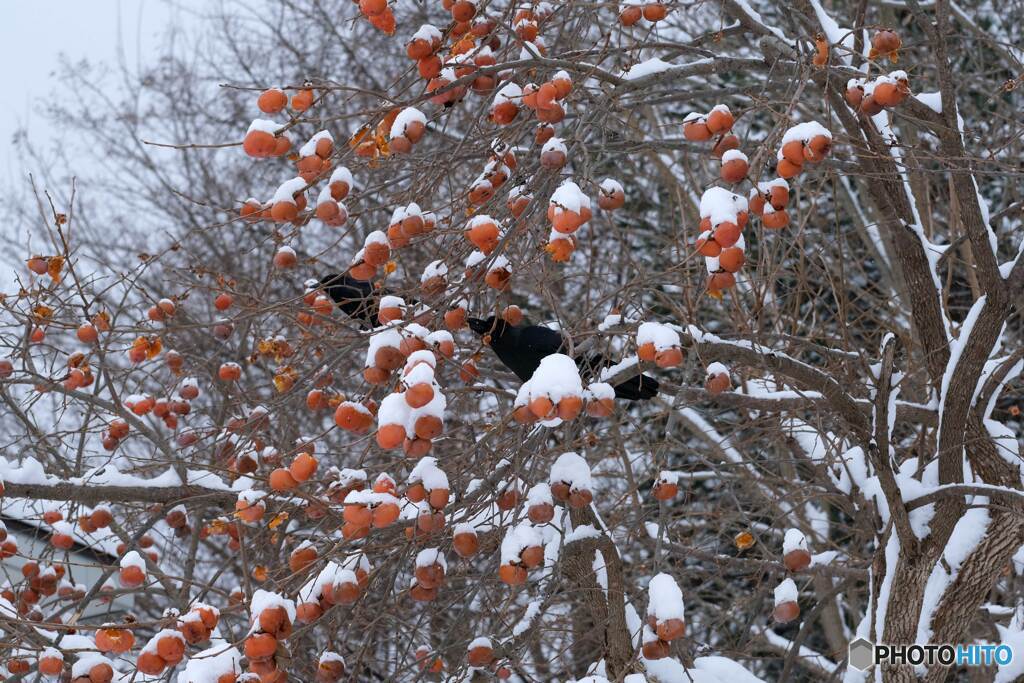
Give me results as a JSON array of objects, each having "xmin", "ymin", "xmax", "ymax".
[{"xmin": 467, "ymin": 315, "xmax": 657, "ymax": 400}]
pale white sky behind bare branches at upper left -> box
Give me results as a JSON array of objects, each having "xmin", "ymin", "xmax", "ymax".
[{"xmin": 0, "ymin": 0, "xmax": 195, "ymax": 291}]
